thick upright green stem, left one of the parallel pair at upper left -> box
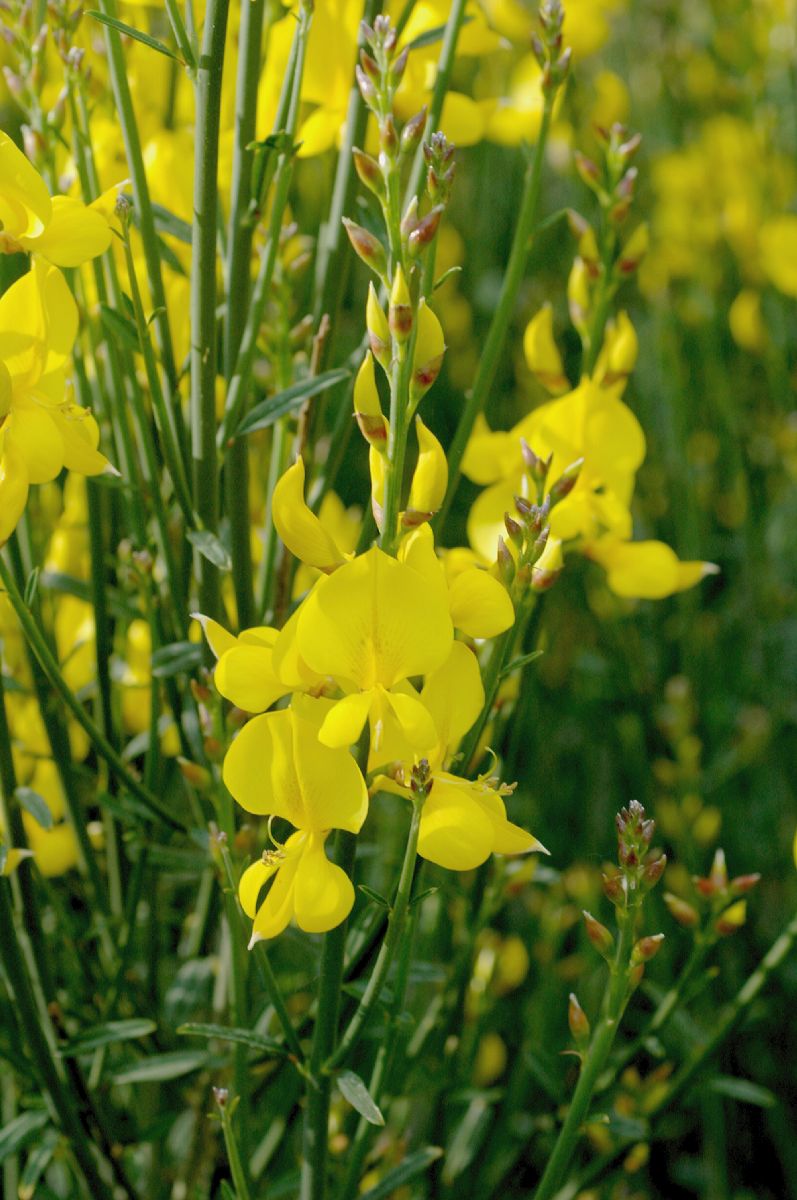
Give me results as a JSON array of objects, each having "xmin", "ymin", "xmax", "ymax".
[{"xmin": 191, "ymin": 0, "xmax": 229, "ymax": 617}]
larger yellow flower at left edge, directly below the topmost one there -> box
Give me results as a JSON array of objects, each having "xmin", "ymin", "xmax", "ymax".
[{"xmin": 0, "ymin": 259, "xmax": 109, "ymax": 544}]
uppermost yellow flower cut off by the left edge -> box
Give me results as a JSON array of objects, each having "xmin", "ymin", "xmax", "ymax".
[{"xmin": 0, "ymin": 130, "xmax": 110, "ymax": 266}]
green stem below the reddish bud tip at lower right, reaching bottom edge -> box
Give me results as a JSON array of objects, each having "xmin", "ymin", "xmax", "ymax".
[{"xmin": 534, "ymin": 901, "xmax": 639, "ymax": 1200}]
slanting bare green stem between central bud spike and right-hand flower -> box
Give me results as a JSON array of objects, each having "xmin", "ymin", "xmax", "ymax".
[{"xmin": 435, "ymin": 91, "xmax": 556, "ymax": 530}]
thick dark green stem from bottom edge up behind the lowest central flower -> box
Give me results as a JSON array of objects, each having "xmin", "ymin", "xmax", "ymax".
[{"xmin": 299, "ymin": 830, "xmax": 356, "ymax": 1200}]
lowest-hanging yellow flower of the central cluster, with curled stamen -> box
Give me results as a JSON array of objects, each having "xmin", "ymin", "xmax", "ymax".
[{"xmin": 223, "ymin": 702, "xmax": 368, "ymax": 947}]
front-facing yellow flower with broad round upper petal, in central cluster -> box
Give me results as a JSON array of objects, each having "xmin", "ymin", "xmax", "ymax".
[{"xmin": 274, "ymin": 547, "xmax": 454, "ymax": 749}]
